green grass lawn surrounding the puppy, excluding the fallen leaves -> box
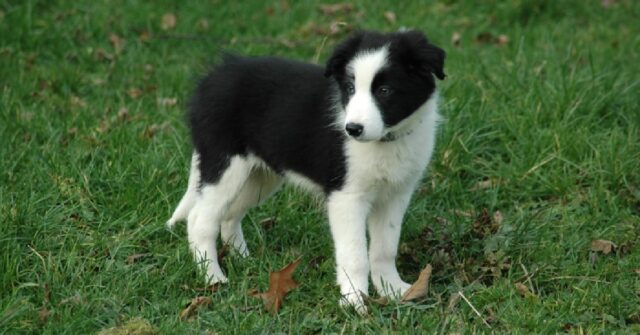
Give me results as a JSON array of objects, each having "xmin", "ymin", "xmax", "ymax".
[{"xmin": 0, "ymin": 0, "xmax": 640, "ymax": 334}]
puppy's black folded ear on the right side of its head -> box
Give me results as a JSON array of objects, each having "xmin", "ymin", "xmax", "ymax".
[{"xmin": 396, "ymin": 30, "xmax": 446, "ymax": 80}]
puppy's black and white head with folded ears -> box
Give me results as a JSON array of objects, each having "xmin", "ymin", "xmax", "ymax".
[{"xmin": 325, "ymin": 31, "xmax": 445, "ymax": 142}]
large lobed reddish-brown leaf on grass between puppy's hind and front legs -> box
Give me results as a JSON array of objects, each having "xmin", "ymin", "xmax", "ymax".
[{"xmin": 249, "ymin": 257, "xmax": 301, "ymax": 314}]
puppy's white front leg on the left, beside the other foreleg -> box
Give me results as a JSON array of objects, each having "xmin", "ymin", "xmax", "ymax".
[{"xmin": 327, "ymin": 192, "xmax": 371, "ymax": 313}]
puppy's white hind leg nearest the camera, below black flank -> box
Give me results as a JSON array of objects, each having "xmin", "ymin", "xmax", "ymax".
[{"xmin": 187, "ymin": 156, "xmax": 251, "ymax": 284}]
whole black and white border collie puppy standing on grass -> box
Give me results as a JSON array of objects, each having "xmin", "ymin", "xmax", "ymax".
[{"xmin": 167, "ymin": 31, "xmax": 445, "ymax": 311}]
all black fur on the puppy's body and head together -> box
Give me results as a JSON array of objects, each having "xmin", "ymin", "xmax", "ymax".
[{"xmin": 189, "ymin": 32, "xmax": 444, "ymax": 193}]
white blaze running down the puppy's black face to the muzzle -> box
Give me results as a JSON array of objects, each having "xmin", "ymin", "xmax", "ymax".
[{"xmin": 344, "ymin": 46, "xmax": 389, "ymax": 141}]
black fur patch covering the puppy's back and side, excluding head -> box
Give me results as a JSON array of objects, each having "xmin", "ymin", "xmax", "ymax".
[{"xmin": 190, "ymin": 56, "xmax": 345, "ymax": 192}]
